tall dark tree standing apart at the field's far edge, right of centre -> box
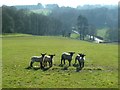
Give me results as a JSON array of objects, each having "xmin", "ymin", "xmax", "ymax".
[{"xmin": 77, "ymin": 15, "xmax": 88, "ymax": 40}]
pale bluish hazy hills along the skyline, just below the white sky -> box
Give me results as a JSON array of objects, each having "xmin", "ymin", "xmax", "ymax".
[{"xmin": 15, "ymin": 3, "xmax": 118, "ymax": 10}]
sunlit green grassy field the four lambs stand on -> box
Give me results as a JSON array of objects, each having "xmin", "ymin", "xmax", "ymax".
[{"xmin": 2, "ymin": 36, "xmax": 118, "ymax": 88}]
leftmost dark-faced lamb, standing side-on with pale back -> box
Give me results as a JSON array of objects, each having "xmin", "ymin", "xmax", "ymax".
[{"xmin": 30, "ymin": 53, "xmax": 46, "ymax": 68}]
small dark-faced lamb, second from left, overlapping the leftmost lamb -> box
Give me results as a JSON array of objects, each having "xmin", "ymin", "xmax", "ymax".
[{"xmin": 43, "ymin": 54, "xmax": 55, "ymax": 67}]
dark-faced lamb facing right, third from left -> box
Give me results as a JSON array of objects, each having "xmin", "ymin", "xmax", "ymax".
[{"xmin": 61, "ymin": 52, "xmax": 75, "ymax": 66}]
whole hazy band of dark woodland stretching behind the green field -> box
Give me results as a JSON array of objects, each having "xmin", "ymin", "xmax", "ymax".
[{"xmin": 2, "ymin": 5, "xmax": 118, "ymax": 41}]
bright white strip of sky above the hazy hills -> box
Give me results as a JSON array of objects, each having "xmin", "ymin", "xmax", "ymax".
[{"xmin": 0, "ymin": 0, "xmax": 119, "ymax": 7}]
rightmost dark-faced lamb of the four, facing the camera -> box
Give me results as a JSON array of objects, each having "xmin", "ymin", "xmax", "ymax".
[{"xmin": 75, "ymin": 53, "xmax": 86, "ymax": 68}]
